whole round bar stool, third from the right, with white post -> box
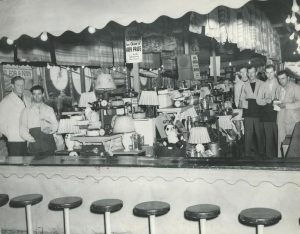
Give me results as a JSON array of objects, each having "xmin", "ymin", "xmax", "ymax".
[{"xmin": 133, "ymin": 201, "xmax": 170, "ymax": 234}]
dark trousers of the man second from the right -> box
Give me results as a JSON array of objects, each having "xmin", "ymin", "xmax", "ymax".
[{"xmin": 263, "ymin": 122, "xmax": 278, "ymax": 158}]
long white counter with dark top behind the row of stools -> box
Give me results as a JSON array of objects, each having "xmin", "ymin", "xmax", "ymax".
[{"xmin": 0, "ymin": 156, "xmax": 300, "ymax": 234}]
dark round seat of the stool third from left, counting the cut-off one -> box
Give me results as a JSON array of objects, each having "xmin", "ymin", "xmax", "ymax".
[{"xmin": 48, "ymin": 197, "xmax": 82, "ymax": 210}]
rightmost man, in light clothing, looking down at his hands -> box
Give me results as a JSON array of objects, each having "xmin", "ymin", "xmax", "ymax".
[{"xmin": 277, "ymin": 70, "xmax": 300, "ymax": 157}]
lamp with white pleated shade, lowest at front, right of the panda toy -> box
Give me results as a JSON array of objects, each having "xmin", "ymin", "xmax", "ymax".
[{"xmin": 189, "ymin": 127, "xmax": 210, "ymax": 157}]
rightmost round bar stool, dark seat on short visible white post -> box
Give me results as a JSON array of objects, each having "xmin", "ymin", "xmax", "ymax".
[{"xmin": 239, "ymin": 208, "xmax": 281, "ymax": 234}]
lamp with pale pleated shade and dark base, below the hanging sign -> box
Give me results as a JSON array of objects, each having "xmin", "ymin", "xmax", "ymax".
[{"xmin": 139, "ymin": 90, "xmax": 159, "ymax": 118}]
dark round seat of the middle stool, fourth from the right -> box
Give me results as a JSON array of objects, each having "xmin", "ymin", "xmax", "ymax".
[{"xmin": 91, "ymin": 199, "xmax": 123, "ymax": 214}]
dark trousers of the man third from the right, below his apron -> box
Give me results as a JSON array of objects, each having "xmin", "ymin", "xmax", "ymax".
[{"xmin": 245, "ymin": 117, "xmax": 264, "ymax": 156}]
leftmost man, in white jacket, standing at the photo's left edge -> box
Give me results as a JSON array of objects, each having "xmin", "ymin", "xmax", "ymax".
[{"xmin": 0, "ymin": 76, "xmax": 30, "ymax": 156}]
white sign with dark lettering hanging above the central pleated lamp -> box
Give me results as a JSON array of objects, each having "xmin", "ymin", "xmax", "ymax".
[{"xmin": 125, "ymin": 27, "xmax": 143, "ymax": 63}]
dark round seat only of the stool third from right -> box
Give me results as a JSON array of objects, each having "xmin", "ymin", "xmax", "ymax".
[{"xmin": 133, "ymin": 201, "xmax": 170, "ymax": 217}]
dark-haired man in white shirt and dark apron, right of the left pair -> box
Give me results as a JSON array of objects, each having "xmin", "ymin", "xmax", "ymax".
[{"xmin": 20, "ymin": 85, "xmax": 58, "ymax": 156}]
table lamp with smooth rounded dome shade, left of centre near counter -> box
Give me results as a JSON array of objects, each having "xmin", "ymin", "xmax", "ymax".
[{"xmin": 113, "ymin": 115, "xmax": 135, "ymax": 151}]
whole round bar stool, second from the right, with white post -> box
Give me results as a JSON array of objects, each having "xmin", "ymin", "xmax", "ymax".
[{"xmin": 184, "ymin": 204, "xmax": 220, "ymax": 234}]
